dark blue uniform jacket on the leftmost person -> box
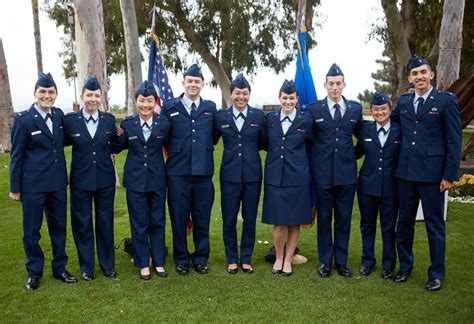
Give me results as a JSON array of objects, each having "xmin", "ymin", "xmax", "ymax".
[{"xmin": 10, "ymin": 105, "xmax": 68, "ymax": 193}]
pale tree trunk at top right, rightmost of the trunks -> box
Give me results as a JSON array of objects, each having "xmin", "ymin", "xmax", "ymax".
[{"xmin": 437, "ymin": 0, "xmax": 464, "ymax": 90}]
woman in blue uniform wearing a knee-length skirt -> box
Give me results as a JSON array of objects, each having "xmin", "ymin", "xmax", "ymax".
[{"xmin": 262, "ymin": 80, "xmax": 313, "ymax": 277}]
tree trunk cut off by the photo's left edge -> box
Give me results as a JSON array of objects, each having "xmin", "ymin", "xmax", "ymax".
[{"xmin": 0, "ymin": 38, "xmax": 13, "ymax": 152}]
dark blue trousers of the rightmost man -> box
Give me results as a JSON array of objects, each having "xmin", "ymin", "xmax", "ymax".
[{"xmin": 396, "ymin": 179, "xmax": 446, "ymax": 279}]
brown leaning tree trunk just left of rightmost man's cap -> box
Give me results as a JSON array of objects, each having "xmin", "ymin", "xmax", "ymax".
[{"xmin": 381, "ymin": 0, "xmax": 411, "ymax": 100}]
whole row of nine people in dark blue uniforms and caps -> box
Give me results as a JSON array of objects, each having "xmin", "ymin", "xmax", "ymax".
[{"xmin": 10, "ymin": 56, "xmax": 461, "ymax": 291}]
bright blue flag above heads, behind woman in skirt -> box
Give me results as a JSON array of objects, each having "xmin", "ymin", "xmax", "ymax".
[{"xmin": 295, "ymin": 28, "xmax": 318, "ymax": 111}]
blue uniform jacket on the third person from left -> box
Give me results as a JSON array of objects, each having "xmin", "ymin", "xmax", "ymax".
[{"xmin": 115, "ymin": 114, "xmax": 170, "ymax": 192}]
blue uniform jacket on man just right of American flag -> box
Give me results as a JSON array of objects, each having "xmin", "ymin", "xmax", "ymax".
[{"xmin": 161, "ymin": 94, "xmax": 217, "ymax": 176}]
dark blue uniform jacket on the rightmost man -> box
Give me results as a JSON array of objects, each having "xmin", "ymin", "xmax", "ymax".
[{"xmin": 392, "ymin": 87, "xmax": 462, "ymax": 182}]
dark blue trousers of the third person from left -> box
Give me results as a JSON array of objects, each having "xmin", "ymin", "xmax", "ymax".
[{"xmin": 127, "ymin": 190, "xmax": 166, "ymax": 268}]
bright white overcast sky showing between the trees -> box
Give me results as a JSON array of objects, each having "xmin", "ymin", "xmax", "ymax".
[{"xmin": 0, "ymin": 0, "xmax": 383, "ymax": 112}]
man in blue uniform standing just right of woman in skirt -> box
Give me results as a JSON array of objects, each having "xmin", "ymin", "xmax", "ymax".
[{"xmin": 309, "ymin": 64, "xmax": 362, "ymax": 278}]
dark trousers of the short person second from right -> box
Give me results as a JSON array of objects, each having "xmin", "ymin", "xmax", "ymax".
[{"xmin": 357, "ymin": 193, "xmax": 398, "ymax": 271}]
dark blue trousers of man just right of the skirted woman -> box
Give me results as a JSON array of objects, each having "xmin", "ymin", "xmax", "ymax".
[{"xmin": 315, "ymin": 184, "xmax": 356, "ymax": 265}]
